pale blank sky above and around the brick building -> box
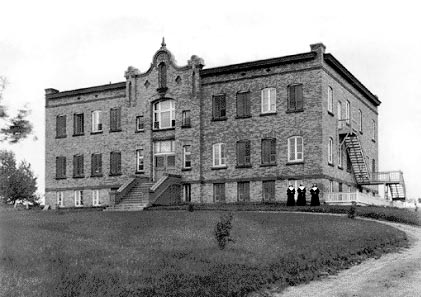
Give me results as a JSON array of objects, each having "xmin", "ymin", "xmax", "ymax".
[{"xmin": 0, "ymin": 0, "xmax": 421, "ymax": 198}]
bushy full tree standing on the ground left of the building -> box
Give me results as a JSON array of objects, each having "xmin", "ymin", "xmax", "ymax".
[{"xmin": 0, "ymin": 150, "xmax": 37, "ymax": 202}]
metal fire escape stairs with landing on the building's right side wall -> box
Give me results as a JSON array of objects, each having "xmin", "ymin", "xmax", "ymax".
[{"xmin": 338, "ymin": 119, "xmax": 406, "ymax": 200}]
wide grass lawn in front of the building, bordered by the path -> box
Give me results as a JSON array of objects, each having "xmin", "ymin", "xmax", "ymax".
[{"xmin": 0, "ymin": 211, "xmax": 407, "ymax": 297}]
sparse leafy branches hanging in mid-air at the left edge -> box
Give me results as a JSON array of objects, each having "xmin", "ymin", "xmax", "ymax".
[{"xmin": 0, "ymin": 76, "xmax": 33, "ymax": 143}]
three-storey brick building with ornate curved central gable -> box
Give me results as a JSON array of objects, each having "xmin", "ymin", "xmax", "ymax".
[{"xmin": 46, "ymin": 41, "xmax": 399, "ymax": 209}]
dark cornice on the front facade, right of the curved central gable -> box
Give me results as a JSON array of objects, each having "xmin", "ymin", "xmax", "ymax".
[{"xmin": 200, "ymin": 52, "xmax": 317, "ymax": 77}]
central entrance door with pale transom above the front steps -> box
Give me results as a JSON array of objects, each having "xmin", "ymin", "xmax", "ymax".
[{"xmin": 153, "ymin": 140, "xmax": 175, "ymax": 181}]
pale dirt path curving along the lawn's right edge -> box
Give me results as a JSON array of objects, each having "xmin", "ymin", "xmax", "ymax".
[{"xmin": 267, "ymin": 222, "xmax": 421, "ymax": 297}]
